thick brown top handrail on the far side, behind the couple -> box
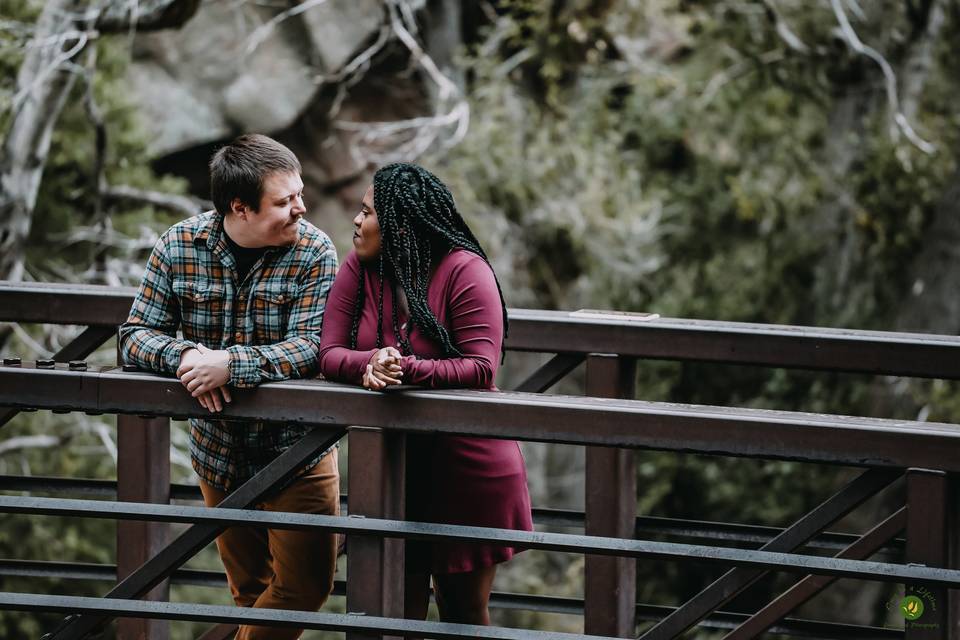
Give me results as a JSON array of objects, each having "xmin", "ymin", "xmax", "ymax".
[{"xmin": 0, "ymin": 281, "xmax": 960, "ymax": 379}]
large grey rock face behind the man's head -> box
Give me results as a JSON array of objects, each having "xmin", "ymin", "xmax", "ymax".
[{"xmin": 129, "ymin": 0, "xmax": 462, "ymax": 245}]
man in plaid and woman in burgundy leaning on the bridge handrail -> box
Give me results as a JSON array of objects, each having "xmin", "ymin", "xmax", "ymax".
[{"xmin": 120, "ymin": 135, "xmax": 532, "ymax": 639}]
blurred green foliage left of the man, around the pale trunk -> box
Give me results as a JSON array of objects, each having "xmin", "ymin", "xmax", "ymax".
[{"xmin": 0, "ymin": 1, "xmax": 186, "ymax": 638}]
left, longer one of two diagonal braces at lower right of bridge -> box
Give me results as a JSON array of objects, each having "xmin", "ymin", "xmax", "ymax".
[{"xmin": 639, "ymin": 469, "xmax": 902, "ymax": 640}]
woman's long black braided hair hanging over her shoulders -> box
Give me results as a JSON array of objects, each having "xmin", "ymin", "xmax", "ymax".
[{"xmin": 350, "ymin": 162, "xmax": 507, "ymax": 358}]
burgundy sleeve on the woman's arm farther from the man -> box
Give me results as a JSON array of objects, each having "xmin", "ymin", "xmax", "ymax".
[{"xmin": 402, "ymin": 252, "xmax": 503, "ymax": 389}]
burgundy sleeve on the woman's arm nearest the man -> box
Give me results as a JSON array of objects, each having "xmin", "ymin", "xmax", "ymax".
[{"xmin": 320, "ymin": 251, "xmax": 376, "ymax": 384}]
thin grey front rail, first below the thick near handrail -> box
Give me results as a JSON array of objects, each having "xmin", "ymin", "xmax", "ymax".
[{"xmin": 0, "ymin": 496, "xmax": 960, "ymax": 588}]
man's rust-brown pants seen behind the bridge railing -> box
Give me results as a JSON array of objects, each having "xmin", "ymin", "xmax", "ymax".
[{"xmin": 200, "ymin": 449, "xmax": 340, "ymax": 640}]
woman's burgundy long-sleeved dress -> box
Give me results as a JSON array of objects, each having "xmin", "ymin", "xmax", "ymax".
[{"xmin": 320, "ymin": 249, "xmax": 533, "ymax": 574}]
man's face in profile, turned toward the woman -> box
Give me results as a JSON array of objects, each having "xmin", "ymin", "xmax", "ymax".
[{"xmin": 234, "ymin": 173, "xmax": 307, "ymax": 247}]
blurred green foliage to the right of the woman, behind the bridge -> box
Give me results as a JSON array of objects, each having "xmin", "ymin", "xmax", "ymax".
[{"xmin": 427, "ymin": 0, "xmax": 960, "ymax": 632}]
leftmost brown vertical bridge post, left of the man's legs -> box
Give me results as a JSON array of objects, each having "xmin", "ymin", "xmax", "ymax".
[{"xmin": 117, "ymin": 415, "xmax": 170, "ymax": 640}]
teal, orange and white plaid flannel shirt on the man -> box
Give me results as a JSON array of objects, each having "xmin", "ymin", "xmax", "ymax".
[{"xmin": 120, "ymin": 212, "xmax": 337, "ymax": 491}]
